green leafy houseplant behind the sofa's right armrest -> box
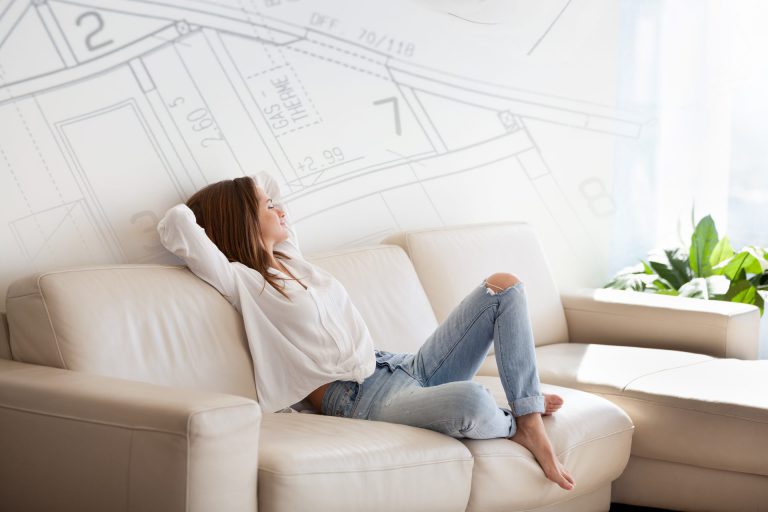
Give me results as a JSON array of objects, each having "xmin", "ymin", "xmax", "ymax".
[{"xmin": 605, "ymin": 215, "xmax": 768, "ymax": 316}]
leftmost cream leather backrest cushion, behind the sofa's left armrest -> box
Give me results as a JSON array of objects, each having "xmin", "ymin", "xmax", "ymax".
[{"xmin": 6, "ymin": 265, "xmax": 256, "ymax": 398}]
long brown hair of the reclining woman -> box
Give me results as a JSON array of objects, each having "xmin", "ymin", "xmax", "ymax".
[{"xmin": 186, "ymin": 176, "xmax": 291, "ymax": 300}]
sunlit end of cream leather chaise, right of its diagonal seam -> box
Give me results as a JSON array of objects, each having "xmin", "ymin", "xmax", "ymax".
[{"xmin": 613, "ymin": 359, "xmax": 768, "ymax": 476}]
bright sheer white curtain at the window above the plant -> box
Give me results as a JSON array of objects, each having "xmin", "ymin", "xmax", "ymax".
[{"xmin": 609, "ymin": 0, "xmax": 768, "ymax": 273}]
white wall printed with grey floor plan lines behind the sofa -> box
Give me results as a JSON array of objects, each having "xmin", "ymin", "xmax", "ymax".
[{"xmin": 0, "ymin": 0, "xmax": 648, "ymax": 309}]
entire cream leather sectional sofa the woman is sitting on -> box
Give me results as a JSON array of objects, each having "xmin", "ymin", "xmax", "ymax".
[{"xmin": 0, "ymin": 223, "xmax": 768, "ymax": 512}]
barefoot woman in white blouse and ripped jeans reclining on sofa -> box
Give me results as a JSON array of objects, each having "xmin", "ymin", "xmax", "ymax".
[{"xmin": 158, "ymin": 172, "xmax": 574, "ymax": 490}]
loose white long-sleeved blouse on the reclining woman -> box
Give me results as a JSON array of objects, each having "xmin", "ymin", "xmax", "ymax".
[{"xmin": 157, "ymin": 172, "xmax": 376, "ymax": 412}]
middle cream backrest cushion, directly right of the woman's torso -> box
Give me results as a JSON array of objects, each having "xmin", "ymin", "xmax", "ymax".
[{"xmin": 307, "ymin": 245, "xmax": 437, "ymax": 353}]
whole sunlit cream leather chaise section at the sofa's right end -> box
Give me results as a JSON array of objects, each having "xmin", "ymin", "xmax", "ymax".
[{"xmin": 537, "ymin": 343, "xmax": 768, "ymax": 476}]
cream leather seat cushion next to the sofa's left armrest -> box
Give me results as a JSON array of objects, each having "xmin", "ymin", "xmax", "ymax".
[{"xmin": 258, "ymin": 413, "xmax": 474, "ymax": 512}]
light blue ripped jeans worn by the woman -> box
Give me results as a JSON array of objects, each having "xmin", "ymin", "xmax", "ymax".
[{"xmin": 322, "ymin": 281, "xmax": 545, "ymax": 439}]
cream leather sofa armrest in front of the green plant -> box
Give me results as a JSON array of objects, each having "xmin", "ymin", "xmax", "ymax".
[{"xmin": 560, "ymin": 289, "xmax": 760, "ymax": 359}]
